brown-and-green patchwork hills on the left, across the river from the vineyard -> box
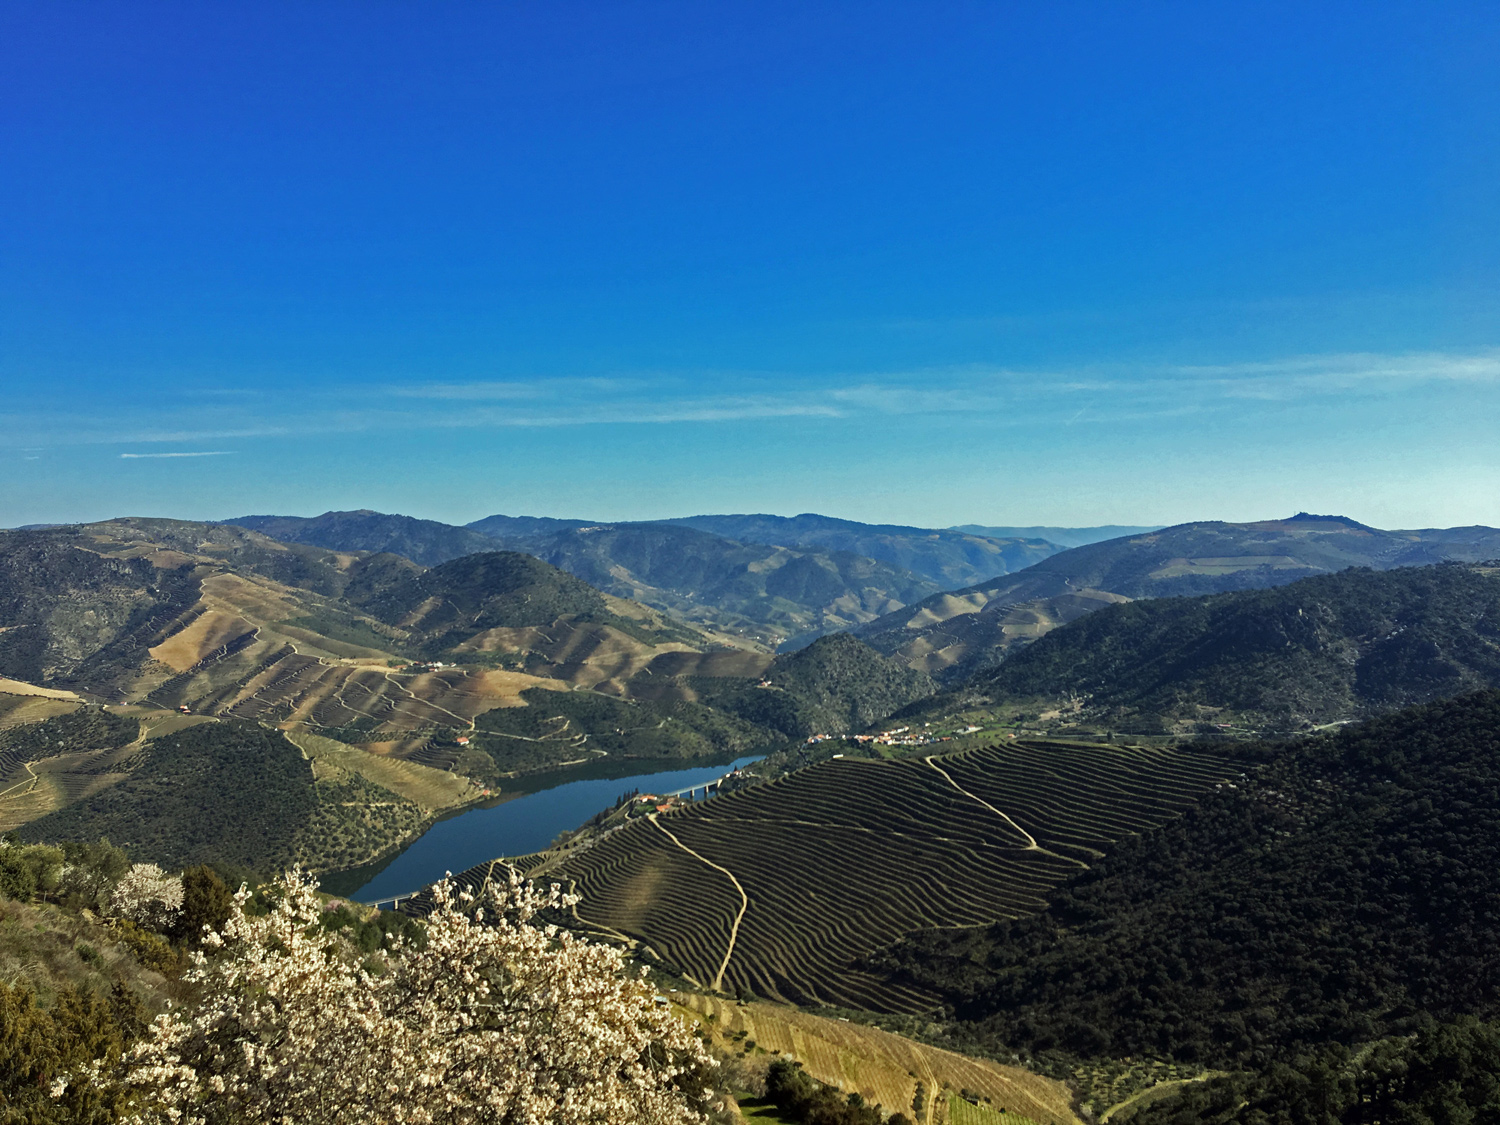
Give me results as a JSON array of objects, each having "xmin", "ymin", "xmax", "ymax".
[{"xmin": 0, "ymin": 521, "xmax": 930, "ymax": 870}]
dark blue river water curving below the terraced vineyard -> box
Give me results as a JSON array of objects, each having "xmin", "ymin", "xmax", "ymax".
[{"xmin": 340, "ymin": 758, "xmax": 758, "ymax": 903}]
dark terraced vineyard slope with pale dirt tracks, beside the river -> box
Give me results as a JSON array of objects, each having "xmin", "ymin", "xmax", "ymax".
[{"xmin": 542, "ymin": 743, "xmax": 1236, "ymax": 1011}]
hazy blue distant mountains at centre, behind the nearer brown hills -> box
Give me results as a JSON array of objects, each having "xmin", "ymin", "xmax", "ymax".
[{"xmin": 231, "ymin": 510, "xmax": 1061, "ymax": 648}]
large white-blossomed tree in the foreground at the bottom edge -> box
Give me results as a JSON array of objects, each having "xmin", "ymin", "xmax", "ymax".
[{"xmin": 117, "ymin": 872, "xmax": 713, "ymax": 1125}]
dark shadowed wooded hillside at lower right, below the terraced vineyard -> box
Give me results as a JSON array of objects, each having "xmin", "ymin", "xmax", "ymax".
[{"xmin": 878, "ymin": 692, "xmax": 1500, "ymax": 1073}]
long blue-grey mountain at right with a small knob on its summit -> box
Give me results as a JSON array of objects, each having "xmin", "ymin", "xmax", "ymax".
[{"xmin": 855, "ymin": 513, "xmax": 1500, "ymax": 684}]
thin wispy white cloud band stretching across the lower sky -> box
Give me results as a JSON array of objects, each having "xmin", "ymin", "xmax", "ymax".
[{"xmin": 0, "ymin": 350, "xmax": 1500, "ymax": 459}]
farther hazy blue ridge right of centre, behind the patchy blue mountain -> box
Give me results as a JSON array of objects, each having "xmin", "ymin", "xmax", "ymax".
[{"xmin": 660, "ymin": 513, "xmax": 1062, "ymax": 590}]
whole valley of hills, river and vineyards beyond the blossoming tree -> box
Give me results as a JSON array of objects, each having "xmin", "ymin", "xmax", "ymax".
[{"xmin": 0, "ymin": 513, "xmax": 1500, "ymax": 1125}]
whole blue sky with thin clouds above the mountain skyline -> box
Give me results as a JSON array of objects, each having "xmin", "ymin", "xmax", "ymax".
[{"xmin": 0, "ymin": 0, "xmax": 1500, "ymax": 527}]
